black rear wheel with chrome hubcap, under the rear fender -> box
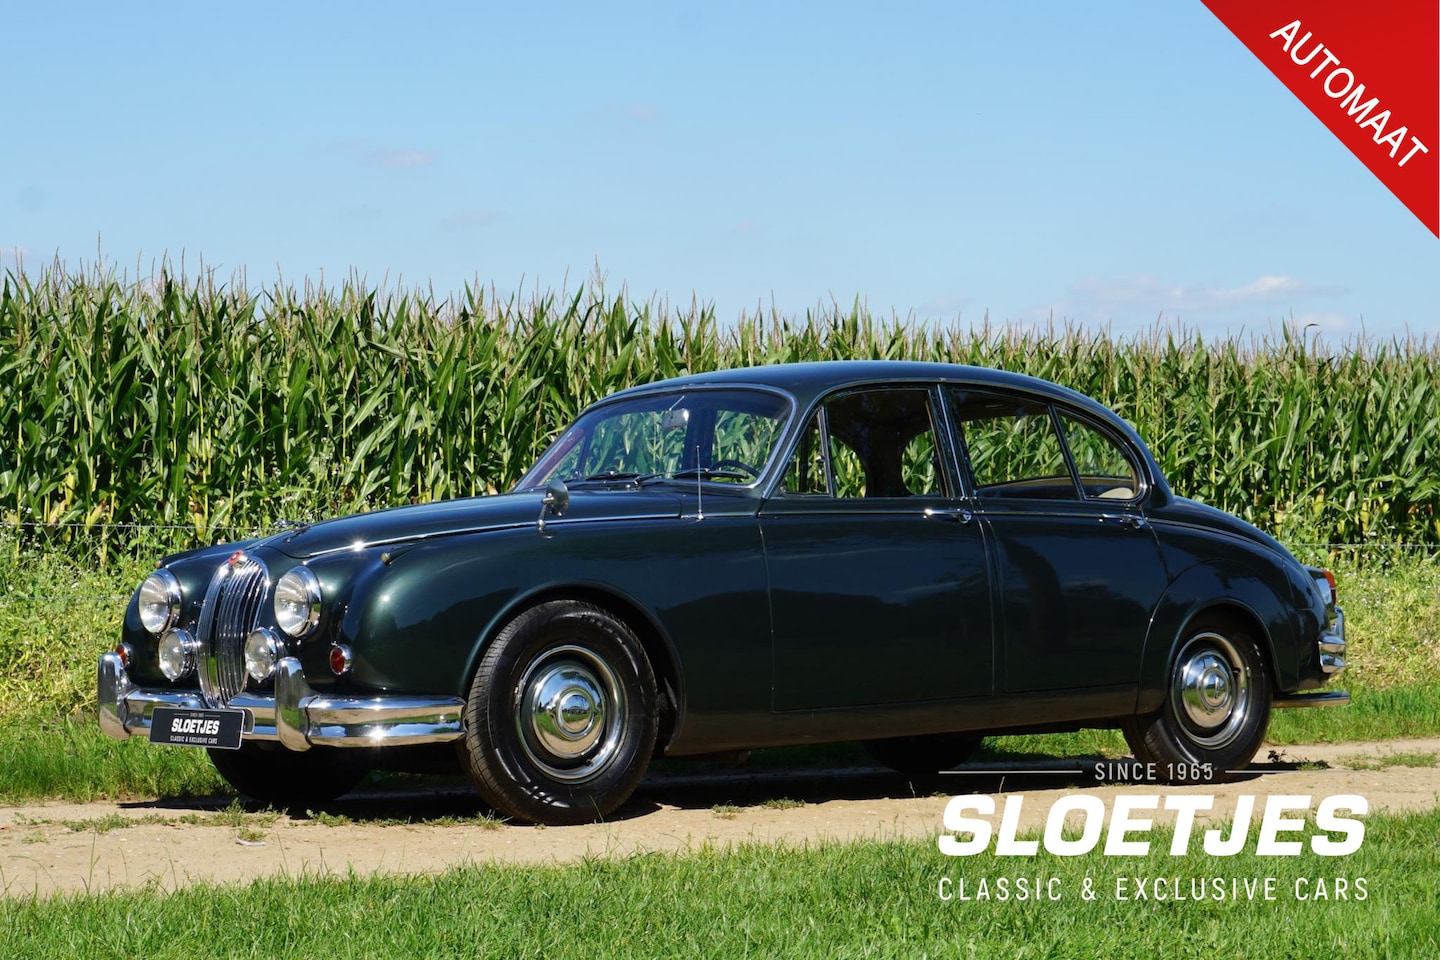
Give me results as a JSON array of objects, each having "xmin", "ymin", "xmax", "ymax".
[{"xmin": 1120, "ymin": 617, "xmax": 1272, "ymax": 783}]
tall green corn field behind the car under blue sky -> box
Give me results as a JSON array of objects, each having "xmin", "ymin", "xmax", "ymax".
[{"xmin": 0, "ymin": 266, "xmax": 1440, "ymax": 558}]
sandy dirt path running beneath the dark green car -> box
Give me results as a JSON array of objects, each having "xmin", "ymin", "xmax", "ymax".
[{"xmin": 0, "ymin": 740, "xmax": 1440, "ymax": 897}]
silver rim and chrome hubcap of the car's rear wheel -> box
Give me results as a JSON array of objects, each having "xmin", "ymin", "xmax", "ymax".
[{"xmin": 1171, "ymin": 632, "xmax": 1250, "ymax": 748}]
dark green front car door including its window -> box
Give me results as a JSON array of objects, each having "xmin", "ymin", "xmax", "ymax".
[{"xmin": 760, "ymin": 386, "xmax": 995, "ymax": 711}]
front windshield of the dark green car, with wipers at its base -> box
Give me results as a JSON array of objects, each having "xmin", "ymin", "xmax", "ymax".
[{"xmin": 516, "ymin": 390, "xmax": 791, "ymax": 489}]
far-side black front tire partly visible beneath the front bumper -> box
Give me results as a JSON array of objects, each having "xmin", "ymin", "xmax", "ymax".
[{"xmin": 209, "ymin": 741, "xmax": 370, "ymax": 810}]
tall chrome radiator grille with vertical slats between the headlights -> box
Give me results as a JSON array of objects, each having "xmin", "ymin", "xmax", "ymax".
[{"xmin": 196, "ymin": 553, "xmax": 269, "ymax": 707}]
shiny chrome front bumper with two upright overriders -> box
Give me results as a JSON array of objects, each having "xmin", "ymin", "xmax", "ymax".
[{"xmin": 96, "ymin": 653, "xmax": 465, "ymax": 750}]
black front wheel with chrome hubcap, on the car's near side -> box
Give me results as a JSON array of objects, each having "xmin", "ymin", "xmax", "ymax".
[{"xmin": 458, "ymin": 600, "xmax": 658, "ymax": 826}]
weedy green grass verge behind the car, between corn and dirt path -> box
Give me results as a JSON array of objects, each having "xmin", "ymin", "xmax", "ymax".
[{"xmin": 0, "ymin": 532, "xmax": 1440, "ymax": 802}]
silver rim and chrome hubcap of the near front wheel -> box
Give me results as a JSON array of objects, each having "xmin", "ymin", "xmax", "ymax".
[{"xmin": 516, "ymin": 646, "xmax": 625, "ymax": 780}]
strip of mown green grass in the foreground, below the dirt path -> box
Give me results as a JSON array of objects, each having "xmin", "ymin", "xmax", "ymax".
[{"xmin": 0, "ymin": 812, "xmax": 1440, "ymax": 960}]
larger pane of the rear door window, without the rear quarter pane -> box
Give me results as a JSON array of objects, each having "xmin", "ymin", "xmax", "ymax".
[{"xmin": 952, "ymin": 390, "xmax": 1079, "ymax": 499}]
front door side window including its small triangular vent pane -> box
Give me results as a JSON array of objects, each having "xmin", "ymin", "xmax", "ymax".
[{"xmin": 785, "ymin": 387, "xmax": 948, "ymax": 498}]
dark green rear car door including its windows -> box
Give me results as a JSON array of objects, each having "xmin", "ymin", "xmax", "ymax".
[{"xmin": 946, "ymin": 387, "xmax": 1166, "ymax": 694}]
